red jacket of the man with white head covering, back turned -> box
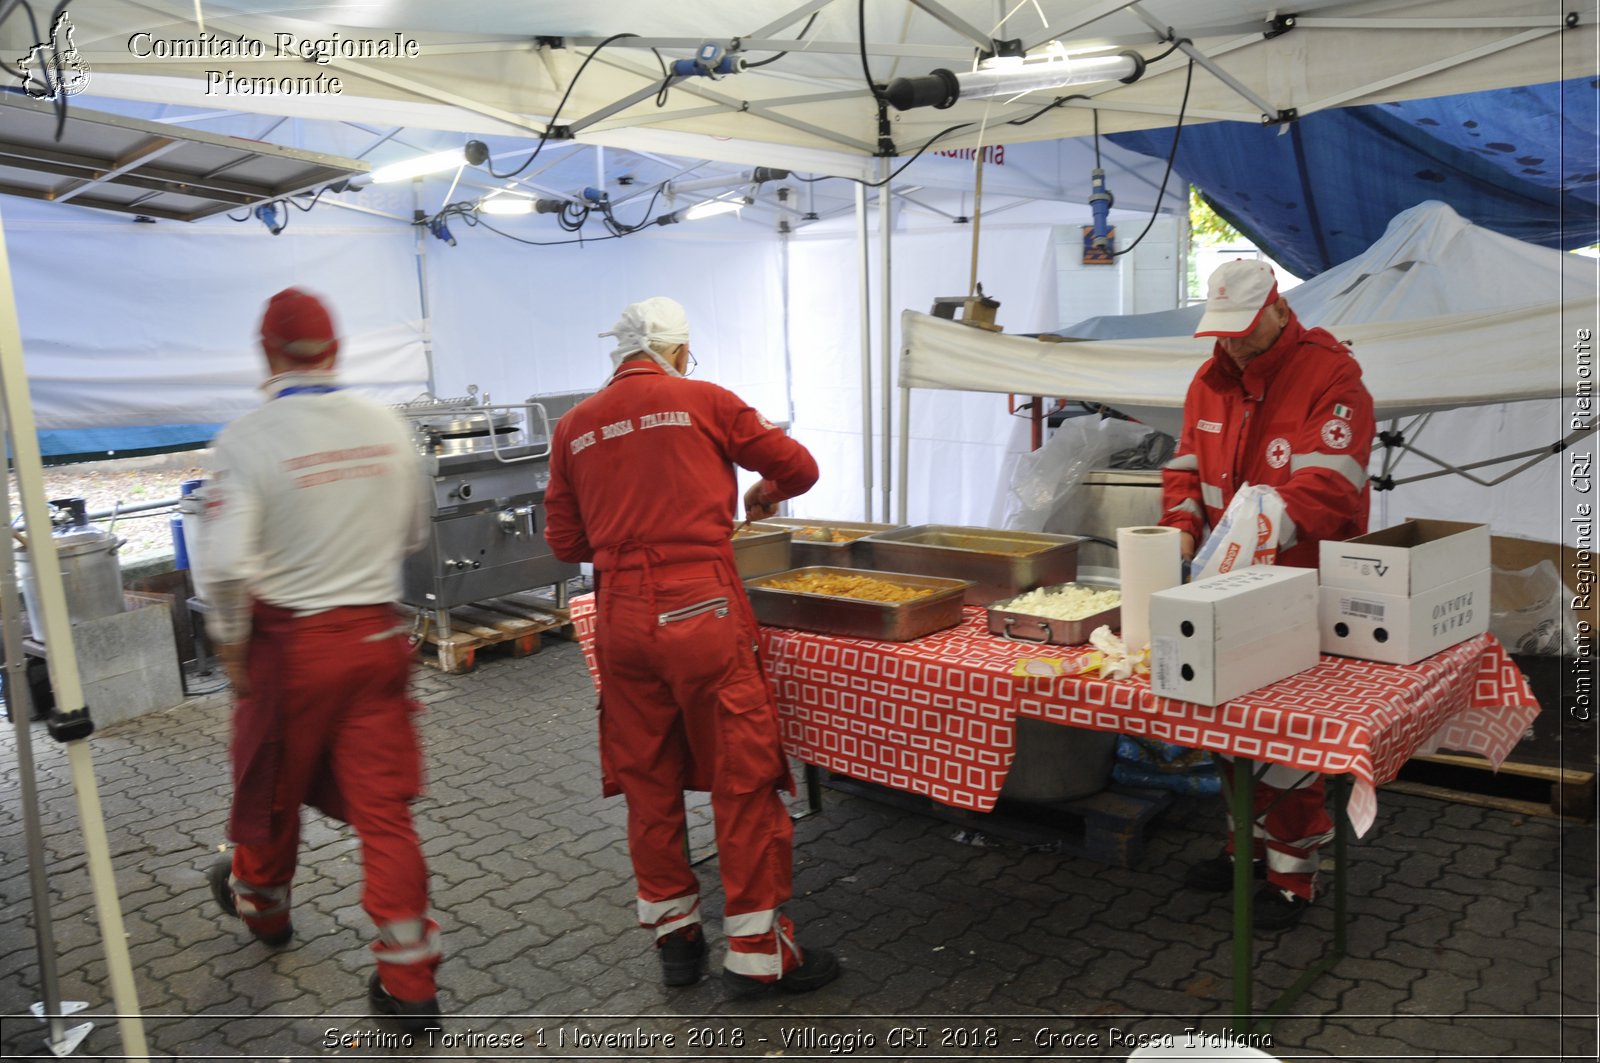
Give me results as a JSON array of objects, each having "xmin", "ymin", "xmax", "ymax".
[{"xmin": 544, "ymin": 360, "xmax": 818, "ymax": 572}]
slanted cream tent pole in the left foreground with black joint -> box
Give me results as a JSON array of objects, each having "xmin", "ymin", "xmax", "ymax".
[{"xmin": 0, "ymin": 204, "xmax": 149, "ymax": 1060}]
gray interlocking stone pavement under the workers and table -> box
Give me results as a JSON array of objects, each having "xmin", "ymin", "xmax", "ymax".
[{"xmin": 0, "ymin": 642, "xmax": 1600, "ymax": 1060}]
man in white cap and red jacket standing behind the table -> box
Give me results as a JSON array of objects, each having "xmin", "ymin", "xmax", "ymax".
[{"xmin": 1160, "ymin": 259, "xmax": 1374, "ymax": 929}]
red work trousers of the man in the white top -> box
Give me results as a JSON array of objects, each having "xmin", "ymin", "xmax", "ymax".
[{"xmin": 229, "ymin": 604, "xmax": 437, "ymax": 1001}]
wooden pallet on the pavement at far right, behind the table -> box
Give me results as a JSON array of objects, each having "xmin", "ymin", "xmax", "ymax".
[{"xmin": 1384, "ymin": 754, "xmax": 1595, "ymax": 823}]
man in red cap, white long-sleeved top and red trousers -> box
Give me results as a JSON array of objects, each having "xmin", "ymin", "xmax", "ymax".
[{"xmin": 202, "ymin": 288, "xmax": 440, "ymax": 1033}]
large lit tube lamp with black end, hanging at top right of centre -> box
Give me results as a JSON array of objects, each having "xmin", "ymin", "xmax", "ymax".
[{"xmin": 883, "ymin": 43, "xmax": 1144, "ymax": 110}]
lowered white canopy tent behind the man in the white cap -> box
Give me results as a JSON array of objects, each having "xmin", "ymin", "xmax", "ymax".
[{"xmin": 899, "ymin": 203, "xmax": 1600, "ymax": 540}]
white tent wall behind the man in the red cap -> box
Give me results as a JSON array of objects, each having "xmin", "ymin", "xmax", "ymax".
[{"xmin": 6, "ymin": 200, "xmax": 427, "ymax": 429}]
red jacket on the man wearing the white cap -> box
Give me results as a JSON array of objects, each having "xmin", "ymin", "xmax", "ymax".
[{"xmin": 1162, "ymin": 314, "xmax": 1374, "ymax": 568}]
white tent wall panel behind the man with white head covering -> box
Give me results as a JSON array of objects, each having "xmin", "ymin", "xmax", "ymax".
[{"xmin": 413, "ymin": 218, "xmax": 789, "ymax": 419}]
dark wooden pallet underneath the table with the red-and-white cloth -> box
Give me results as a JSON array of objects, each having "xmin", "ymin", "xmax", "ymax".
[{"xmin": 827, "ymin": 773, "xmax": 1173, "ymax": 868}]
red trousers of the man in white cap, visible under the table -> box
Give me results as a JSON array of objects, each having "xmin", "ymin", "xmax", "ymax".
[{"xmin": 1218, "ymin": 757, "xmax": 1333, "ymax": 900}]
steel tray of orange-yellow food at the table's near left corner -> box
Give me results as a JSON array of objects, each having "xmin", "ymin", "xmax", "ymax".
[{"xmin": 744, "ymin": 565, "xmax": 966, "ymax": 642}]
